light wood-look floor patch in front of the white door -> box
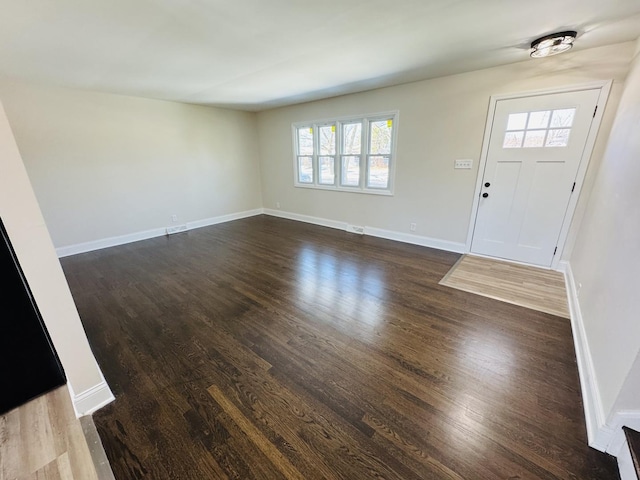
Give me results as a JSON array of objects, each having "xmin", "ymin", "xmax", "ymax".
[{"xmin": 440, "ymin": 255, "xmax": 569, "ymax": 318}]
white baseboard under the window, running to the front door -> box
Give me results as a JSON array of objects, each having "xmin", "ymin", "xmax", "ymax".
[{"xmin": 263, "ymin": 208, "xmax": 466, "ymax": 253}]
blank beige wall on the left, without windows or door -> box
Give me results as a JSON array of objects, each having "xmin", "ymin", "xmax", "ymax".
[{"xmin": 0, "ymin": 82, "xmax": 262, "ymax": 248}]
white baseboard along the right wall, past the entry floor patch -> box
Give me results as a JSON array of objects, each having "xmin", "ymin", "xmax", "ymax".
[{"xmin": 559, "ymin": 262, "xmax": 615, "ymax": 452}]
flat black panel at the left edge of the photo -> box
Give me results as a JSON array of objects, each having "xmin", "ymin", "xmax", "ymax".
[{"xmin": 0, "ymin": 219, "xmax": 66, "ymax": 414}]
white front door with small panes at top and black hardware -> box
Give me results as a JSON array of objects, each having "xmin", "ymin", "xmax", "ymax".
[{"xmin": 471, "ymin": 88, "xmax": 600, "ymax": 267}]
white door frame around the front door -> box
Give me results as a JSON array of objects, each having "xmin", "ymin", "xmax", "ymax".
[{"xmin": 465, "ymin": 80, "xmax": 613, "ymax": 270}]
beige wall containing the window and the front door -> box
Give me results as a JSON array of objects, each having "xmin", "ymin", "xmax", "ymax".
[{"xmin": 258, "ymin": 42, "xmax": 634, "ymax": 253}]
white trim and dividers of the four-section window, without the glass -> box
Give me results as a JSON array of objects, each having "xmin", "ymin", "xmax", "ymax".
[{"xmin": 291, "ymin": 110, "xmax": 400, "ymax": 196}]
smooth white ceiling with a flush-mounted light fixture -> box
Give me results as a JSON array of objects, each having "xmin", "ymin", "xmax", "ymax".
[{"xmin": 0, "ymin": 0, "xmax": 640, "ymax": 110}]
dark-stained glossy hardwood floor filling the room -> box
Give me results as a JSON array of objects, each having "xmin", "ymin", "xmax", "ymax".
[{"xmin": 62, "ymin": 216, "xmax": 618, "ymax": 480}]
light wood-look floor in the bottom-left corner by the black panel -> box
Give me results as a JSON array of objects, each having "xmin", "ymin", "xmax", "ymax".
[{"xmin": 0, "ymin": 386, "xmax": 98, "ymax": 480}]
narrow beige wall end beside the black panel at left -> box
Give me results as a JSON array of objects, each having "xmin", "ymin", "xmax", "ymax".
[{"xmin": 0, "ymin": 104, "xmax": 110, "ymax": 404}]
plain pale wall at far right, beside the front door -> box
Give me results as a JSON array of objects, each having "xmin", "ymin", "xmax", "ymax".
[{"xmin": 570, "ymin": 41, "xmax": 640, "ymax": 416}]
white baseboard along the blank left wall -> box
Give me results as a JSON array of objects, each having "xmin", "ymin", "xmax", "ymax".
[{"xmin": 56, "ymin": 208, "xmax": 263, "ymax": 258}]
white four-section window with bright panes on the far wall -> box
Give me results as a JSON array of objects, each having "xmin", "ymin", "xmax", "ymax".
[{"xmin": 293, "ymin": 112, "xmax": 398, "ymax": 195}]
